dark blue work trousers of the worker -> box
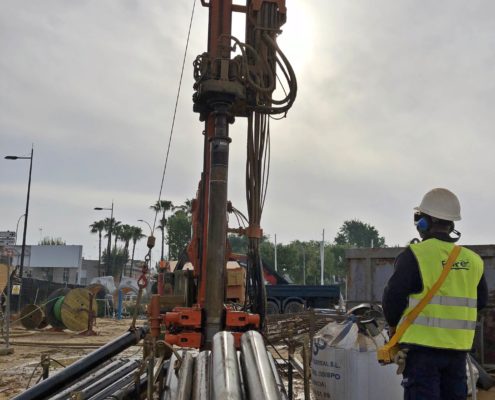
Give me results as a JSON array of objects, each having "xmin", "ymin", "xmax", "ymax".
[{"xmin": 402, "ymin": 346, "xmax": 467, "ymax": 400}]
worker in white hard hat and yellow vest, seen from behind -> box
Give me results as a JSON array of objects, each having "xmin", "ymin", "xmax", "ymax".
[{"xmin": 383, "ymin": 188, "xmax": 488, "ymax": 400}]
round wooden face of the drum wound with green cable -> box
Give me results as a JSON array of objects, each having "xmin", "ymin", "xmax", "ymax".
[{"xmin": 60, "ymin": 288, "xmax": 96, "ymax": 332}]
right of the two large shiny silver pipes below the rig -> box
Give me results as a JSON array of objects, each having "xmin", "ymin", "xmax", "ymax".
[{"xmin": 241, "ymin": 331, "xmax": 280, "ymax": 400}]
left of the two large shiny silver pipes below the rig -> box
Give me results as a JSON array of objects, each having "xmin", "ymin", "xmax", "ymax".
[{"xmin": 212, "ymin": 331, "xmax": 243, "ymax": 400}]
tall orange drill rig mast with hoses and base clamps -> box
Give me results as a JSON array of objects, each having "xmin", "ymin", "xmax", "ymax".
[{"xmin": 161, "ymin": 0, "xmax": 297, "ymax": 348}]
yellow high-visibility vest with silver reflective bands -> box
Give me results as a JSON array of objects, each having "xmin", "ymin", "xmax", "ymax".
[{"xmin": 399, "ymin": 239, "xmax": 483, "ymax": 350}]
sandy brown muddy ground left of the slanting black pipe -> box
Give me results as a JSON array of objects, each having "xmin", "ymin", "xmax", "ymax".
[{"xmin": 0, "ymin": 319, "xmax": 495, "ymax": 400}]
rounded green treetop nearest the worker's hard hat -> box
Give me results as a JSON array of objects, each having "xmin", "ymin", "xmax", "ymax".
[{"xmin": 335, "ymin": 219, "xmax": 385, "ymax": 247}]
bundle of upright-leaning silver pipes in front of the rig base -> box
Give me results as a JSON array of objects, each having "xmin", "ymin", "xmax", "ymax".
[{"xmin": 161, "ymin": 331, "xmax": 287, "ymax": 400}]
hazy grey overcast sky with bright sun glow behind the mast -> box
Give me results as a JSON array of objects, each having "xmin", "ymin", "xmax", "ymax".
[{"xmin": 0, "ymin": 0, "xmax": 495, "ymax": 259}]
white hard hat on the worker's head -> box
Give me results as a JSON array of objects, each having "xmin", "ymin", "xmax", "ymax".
[{"xmin": 414, "ymin": 188, "xmax": 461, "ymax": 221}]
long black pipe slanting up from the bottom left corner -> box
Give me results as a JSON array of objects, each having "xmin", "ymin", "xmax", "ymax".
[{"xmin": 14, "ymin": 326, "xmax": 148, "ymax": 400}]
